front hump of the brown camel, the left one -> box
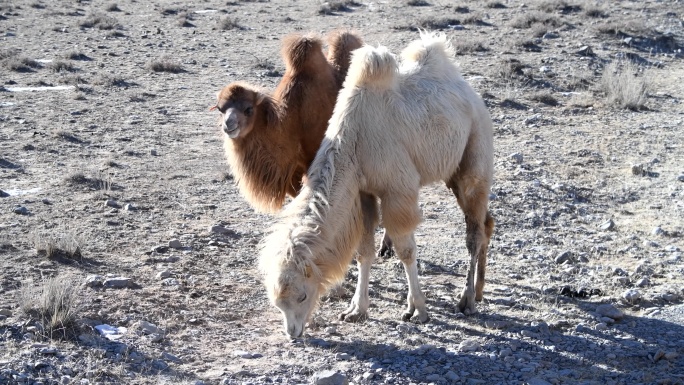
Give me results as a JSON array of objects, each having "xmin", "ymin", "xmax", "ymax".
[{"xmin": 280, "ymin": 34, "xmax": 326, "ymax": 73}]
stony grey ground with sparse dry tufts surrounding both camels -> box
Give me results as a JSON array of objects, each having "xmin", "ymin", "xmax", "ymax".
[{"xmin": 0, "ymin": 0, "xmax": 684, "ymax": 385}]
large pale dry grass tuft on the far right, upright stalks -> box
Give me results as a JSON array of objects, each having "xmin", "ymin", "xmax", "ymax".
[{"xmin": 600, "ymin": 62, "xmax": 649, "ymax": 111}]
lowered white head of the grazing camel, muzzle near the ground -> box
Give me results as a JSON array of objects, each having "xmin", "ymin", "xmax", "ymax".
[{"xmin": 262, "ymin": 246, "xmax": 322, "ymax": 338}]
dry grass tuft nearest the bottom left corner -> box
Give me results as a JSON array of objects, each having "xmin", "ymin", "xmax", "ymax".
[{"xmin": 20, "ymin": 277, "xmax": 80, "ymax": 339}]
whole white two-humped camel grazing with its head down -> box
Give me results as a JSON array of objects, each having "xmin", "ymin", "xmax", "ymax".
[{"xmin": 260, "ymin": 34, "xmax": 494, "ymax": 337}]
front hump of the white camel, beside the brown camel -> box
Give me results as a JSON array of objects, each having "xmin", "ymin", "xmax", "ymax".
[{"xmin": 345, "ymin": 45, "xmax": 397, "ymax": 88}]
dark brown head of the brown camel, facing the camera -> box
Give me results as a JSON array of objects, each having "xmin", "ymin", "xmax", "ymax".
[{"xmin": 211, "ymin": 82, "xmax": 278, "ymax": 140}]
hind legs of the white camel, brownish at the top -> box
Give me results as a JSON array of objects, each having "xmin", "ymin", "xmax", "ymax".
[{"xmin": 447, "ymin": 170, "xmax": 494, "ymax": 315}]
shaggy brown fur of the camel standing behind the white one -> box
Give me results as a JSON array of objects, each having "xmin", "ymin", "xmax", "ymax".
[{"xmin": 216, "ymin": 32, "xmax": 362, "ymax": 212}]
